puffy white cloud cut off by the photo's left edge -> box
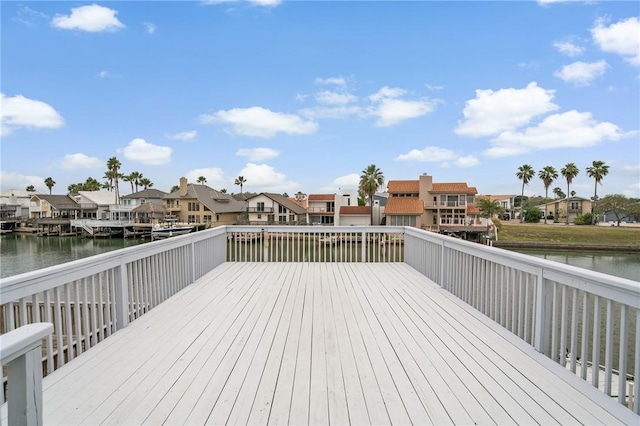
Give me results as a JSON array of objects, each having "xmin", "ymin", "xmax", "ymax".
[{"xmin": 0, "ymin": 93, "xmax": 64, "ymax": 136}]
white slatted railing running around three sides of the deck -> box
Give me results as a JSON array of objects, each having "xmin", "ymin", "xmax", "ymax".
[{"xmin": 0, "ymin": 226, "xmax": 640, "ymax": 413}]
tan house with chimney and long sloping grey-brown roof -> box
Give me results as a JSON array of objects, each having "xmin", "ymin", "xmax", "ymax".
[{"xmin": 163, "ymin": 177, "xmax": 247, "ymax": 226}]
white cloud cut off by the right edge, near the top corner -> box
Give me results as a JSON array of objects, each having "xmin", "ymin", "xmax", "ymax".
[{"xmin": 591, "ymin": 16, "xmax": 640, "ymax": 65}]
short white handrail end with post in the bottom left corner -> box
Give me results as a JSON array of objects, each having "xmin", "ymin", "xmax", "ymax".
[{"xmin": 0, "ymin": 323, "xmax": 53, "ymax": 425}]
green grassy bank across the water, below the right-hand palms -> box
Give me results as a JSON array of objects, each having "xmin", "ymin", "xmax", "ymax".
[{"xmin": 497, "ymin": 223, "xmax": 640, "ymax": 248}]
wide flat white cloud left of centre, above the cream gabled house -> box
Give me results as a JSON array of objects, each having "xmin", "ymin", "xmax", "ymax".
[{"xmin": 201, "ymin": 107, "xmax": 318, "ymax": 138}]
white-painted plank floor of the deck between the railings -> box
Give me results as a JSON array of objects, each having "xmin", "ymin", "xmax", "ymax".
[{"xmin": 3, "ymin": 263, "xmax": 638, "ymax": 425}]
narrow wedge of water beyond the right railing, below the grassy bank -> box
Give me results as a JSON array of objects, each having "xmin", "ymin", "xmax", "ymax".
[{"xmin": 513, "ymin": 249, "xmax": 640, "ymax": 281}]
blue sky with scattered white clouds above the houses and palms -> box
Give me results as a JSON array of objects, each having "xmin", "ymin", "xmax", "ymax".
[{"xmin": 0, "ymin": 0, "xmax": 640, "ymax": 198}]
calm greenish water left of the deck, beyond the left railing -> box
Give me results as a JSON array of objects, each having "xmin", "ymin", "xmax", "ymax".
[{"xmin": 0, "ymin": 233, "xmax": 149, "ymax": 278}]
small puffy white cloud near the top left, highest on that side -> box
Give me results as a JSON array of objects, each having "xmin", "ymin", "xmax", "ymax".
[{"xmin": 51, "ymin": 4, "xmax": 124, "ymax": 33}]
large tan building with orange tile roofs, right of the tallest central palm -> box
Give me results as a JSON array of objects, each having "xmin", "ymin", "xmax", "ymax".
[{"xmin": 385, "ymin": 173, "xmax": 479, "ymax": 230}]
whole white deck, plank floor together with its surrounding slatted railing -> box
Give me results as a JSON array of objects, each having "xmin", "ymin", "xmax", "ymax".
[{"xmin": 0, "ymin": 226, "xmax": 640, "ymax": 424}]
